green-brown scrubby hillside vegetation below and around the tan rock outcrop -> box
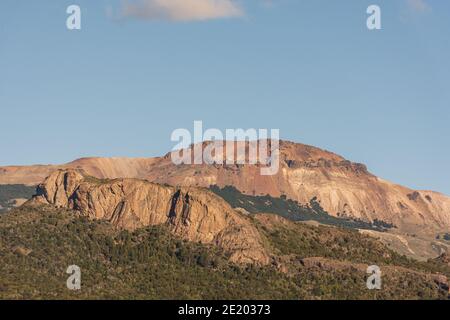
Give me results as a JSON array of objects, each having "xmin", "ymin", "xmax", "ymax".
[{"xmin": 0, "ymin": 206, "xmax": 450, "ymax": 299}]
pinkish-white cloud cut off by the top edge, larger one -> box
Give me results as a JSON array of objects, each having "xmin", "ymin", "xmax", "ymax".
[{"xmin": 122, "ymin": 0, "xmax": 244, "ymax": 21}]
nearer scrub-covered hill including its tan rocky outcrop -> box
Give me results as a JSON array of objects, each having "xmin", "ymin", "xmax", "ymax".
[{"xmin": 0, "ymin": 190, "xmax": 450, "ymax": 300}]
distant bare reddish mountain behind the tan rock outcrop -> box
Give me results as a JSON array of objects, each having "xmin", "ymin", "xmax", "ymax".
[{"xmin": 0, "ymin": 141, "xmax": 450, "ymax": 233}]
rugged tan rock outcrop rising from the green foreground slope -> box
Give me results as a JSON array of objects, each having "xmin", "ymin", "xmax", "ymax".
[{"xmin": 32, "ymin": 169, "xmax": 269, "ymax": 264}]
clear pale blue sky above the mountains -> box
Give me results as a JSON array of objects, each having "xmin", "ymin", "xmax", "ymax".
[{"xmin": 0, "ymin": 0, "xmax": 450, "ymax": 194}]
